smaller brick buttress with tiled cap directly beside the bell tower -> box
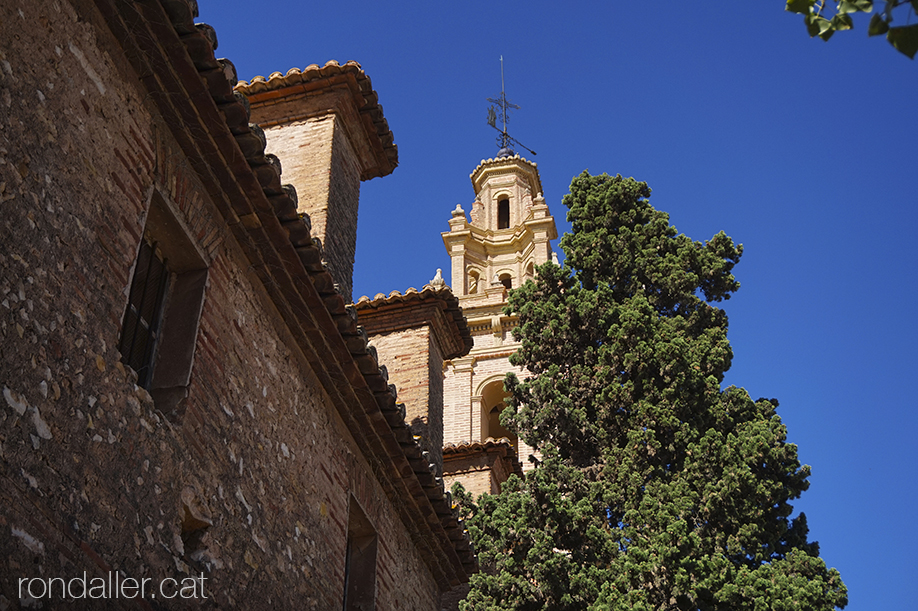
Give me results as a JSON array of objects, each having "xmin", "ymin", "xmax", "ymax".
[{"xmin": 355, "ymin": 284, "xmax": 472, "ymax": 475}]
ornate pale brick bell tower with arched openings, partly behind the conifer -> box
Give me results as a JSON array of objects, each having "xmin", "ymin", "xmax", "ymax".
[{"xmin": 442, "ymin": 145, "xmax": 558, "ymax": 494}]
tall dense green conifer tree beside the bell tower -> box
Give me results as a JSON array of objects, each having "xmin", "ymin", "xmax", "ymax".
[{"xmin": 456, "ymin": 172, "xmax": 847, "ymax": 611}]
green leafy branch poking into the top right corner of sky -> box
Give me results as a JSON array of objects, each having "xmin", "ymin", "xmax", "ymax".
[{"xmin": 785, "ymin": 0, "xmax": 918, "ymax": 59}]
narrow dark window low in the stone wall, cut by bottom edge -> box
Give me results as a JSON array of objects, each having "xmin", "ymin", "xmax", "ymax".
[{"xmin": 344, "ymin": 497, "xmax": 377, "ymax": 611}]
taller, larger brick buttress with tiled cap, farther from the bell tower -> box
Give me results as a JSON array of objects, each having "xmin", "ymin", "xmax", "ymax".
[{"xmin": 236, "ymin": 61, "xmax": 398, "ymax": 301}]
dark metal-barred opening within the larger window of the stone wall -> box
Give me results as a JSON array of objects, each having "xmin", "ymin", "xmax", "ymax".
[{"xmin": 118, "ymin": 240, "xmax": 170, "ymax": 389}]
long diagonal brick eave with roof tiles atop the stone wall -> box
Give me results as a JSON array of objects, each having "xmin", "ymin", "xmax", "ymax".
[{"xmin": 87, "ymin": 0, "xmax": 478, "ymax": 590}]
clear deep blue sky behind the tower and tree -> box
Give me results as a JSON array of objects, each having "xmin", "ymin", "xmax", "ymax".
[{"xmin": 208, "ymin": 0, "xmax": 918, "ymax": 611}]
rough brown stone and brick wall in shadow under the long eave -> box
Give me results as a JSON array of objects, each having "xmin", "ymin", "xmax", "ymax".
[{"xmin": 0, "ymin": 0, "xmax": 437, "ymax": 610}]
